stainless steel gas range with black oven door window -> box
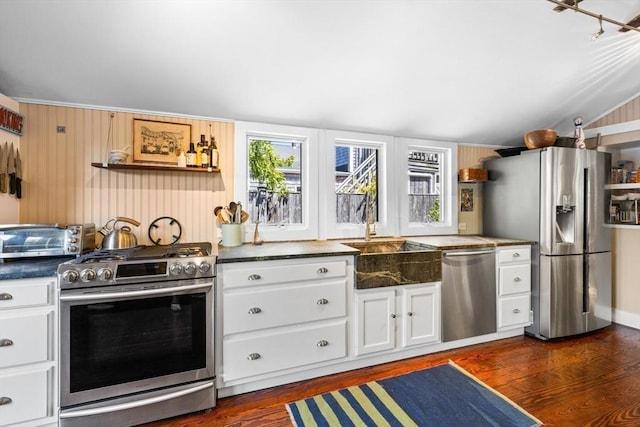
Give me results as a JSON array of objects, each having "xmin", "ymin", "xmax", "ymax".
[{"xmin": 58, "ymin": 243, "xmax": 216, "ymax": 427}]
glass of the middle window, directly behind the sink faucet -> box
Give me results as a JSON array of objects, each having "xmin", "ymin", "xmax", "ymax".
[{"xmin": 335, "ymin": 145, "xmax": 378, "ymax": 224}]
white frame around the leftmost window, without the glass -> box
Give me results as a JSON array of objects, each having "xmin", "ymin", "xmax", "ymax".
[{"xmin": 234, "ymin": 122, "xmax": 319, "ymax": 242}]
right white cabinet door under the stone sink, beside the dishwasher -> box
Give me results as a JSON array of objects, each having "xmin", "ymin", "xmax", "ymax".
[{"xmin": 400, "ymin": 284, "xmax": 440, "ymax": 347}]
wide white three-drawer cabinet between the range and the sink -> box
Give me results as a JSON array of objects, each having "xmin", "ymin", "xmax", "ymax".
[{"xmin": 215, "ymin": 257, "xmax": 353, "ymax": 388}]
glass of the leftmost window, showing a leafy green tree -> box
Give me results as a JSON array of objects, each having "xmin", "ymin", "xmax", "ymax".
[{"xmin": 248, "ymin": 137, "xmax": 303, "ymax": 225}]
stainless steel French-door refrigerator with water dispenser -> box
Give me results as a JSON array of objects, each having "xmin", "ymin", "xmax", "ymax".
[{"xmin": 483, "ymin": 147, "xmax": 611, "ymax": 339}]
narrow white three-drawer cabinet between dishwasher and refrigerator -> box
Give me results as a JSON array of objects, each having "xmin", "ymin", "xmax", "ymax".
[{"xmin": 496, "ymin": 246, "xmax": 531, "ymax": 331}]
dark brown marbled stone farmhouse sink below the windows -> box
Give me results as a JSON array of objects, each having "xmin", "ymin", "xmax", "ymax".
[{"xmin": 343, "ymin": 240, "xmax": 442, "ymax": 289}]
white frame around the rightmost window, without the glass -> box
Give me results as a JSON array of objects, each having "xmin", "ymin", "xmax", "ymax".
[{"xmin": 394, "ymin": 138, "xmax": 458, "ymax": 236}]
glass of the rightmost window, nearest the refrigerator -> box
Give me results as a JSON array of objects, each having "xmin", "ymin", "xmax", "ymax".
[{"xmin": 409, "ymin": 150, "xmax": 442, "ymax": 222}]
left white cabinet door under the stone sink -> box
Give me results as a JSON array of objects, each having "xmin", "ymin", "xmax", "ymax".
[{"xmin": 356, "ymin": 289, "xmax": 396, "ymax": 355}]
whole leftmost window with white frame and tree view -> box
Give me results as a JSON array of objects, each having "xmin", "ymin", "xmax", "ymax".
[{"xmin": 234, "ymin": 122, "xmax": 318, "ymax": 241}]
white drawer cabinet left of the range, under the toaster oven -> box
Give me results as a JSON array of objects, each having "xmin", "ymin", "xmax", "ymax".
[{"xmin": 0, "ymin": 277, "xmax": 58, "ymax": 427}]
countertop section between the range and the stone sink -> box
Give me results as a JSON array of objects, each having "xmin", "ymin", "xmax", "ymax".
[{"xmin": 216, "ymin": 240, "xmax": 360, "ymax": 264}]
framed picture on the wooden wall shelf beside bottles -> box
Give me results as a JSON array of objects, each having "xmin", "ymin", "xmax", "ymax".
[{"xmin": 133, "ymin": 119, "xmax": 191, "ymax": 165}]
